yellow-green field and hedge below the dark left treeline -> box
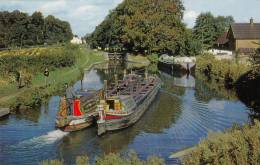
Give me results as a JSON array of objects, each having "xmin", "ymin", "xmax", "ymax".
[{"xmin": 0, "ymin": 45, "xmax": 78, "ymax": 75}]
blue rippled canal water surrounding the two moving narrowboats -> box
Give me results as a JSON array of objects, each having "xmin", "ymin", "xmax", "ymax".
[{"xmin": 0, "ymin": 64, "xmax": 250, "ymax": 165}]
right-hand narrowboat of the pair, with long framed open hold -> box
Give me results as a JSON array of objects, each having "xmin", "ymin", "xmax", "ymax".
[{"xmin": 97, "ymin": 74, "xmax": 161, "ymax": 135}]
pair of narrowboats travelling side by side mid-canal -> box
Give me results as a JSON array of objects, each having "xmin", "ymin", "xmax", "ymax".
[{"xmin": 56, "ymin": 74, "xmax": 161, "ymax": 135}]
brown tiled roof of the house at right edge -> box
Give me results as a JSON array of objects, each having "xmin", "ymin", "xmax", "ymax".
[{"xmin": 231, "ymin": 23, "xmax": 260, "ymax": 39}]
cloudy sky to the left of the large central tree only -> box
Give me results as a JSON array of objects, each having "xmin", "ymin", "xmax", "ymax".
[{"xmin": 0, "ymin": 0, "xmax": 123, "ymax": 36}]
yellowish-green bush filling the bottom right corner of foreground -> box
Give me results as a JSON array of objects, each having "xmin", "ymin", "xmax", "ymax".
[{"xmin": 182, "ymin": 121, "xmax": 260, "ymax": 165}]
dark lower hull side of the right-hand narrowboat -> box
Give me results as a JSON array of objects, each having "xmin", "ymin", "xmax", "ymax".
[{"xmin": 97, "ymin": 81, "xmax": 160, "ymax": 135}]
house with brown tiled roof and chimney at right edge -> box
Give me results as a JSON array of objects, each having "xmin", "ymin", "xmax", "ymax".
[{"xmin": 226, "ymin": 18, "xmax": 260, "ymax": 54}]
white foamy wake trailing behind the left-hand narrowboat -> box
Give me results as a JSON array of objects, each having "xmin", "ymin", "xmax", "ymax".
[{"xmin": 14, "ymin": 130, "xmax": 69, "ymax": 148}]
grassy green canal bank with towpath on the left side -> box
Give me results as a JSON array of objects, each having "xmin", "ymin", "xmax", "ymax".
[{"xmin": 0, "ymin": 46, "xmax": 105, "ymax": 110}]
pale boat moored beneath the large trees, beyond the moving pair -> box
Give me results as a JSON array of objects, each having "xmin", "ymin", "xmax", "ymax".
[{"xmin": 158, "ymin": 54, "xmax": 196, "ymax": 73}]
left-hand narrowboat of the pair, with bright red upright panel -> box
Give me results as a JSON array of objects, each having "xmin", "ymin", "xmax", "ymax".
[{"xmin": 56, "ymin": 90, "xmax": 101, "ymax": 132}]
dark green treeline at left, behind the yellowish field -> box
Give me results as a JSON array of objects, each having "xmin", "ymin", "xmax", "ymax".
[{"xmin": 0, "ymin": 10, "xmax": 73, "ymax": 48}]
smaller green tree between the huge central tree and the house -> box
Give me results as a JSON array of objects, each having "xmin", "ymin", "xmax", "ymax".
[{"xmin": 194, "ymin": 12, "xmax": 234, "ymax": 49}]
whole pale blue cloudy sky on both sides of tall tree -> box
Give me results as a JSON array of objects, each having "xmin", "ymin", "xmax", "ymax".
[{"xmin": 0, "ymin": 0, "xmax": 260, "ymax": 36}]
